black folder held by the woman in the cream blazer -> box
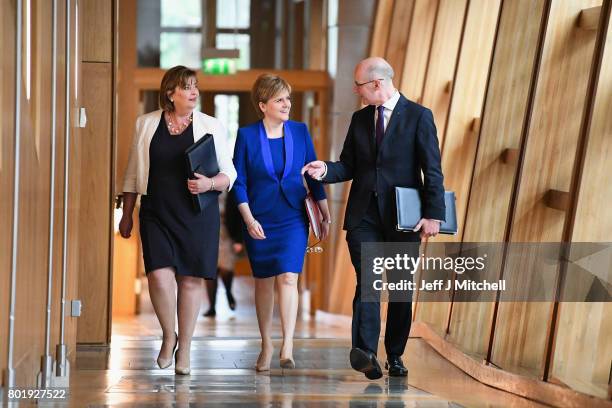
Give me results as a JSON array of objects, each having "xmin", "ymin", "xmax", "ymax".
[{"xmin": 185, "ymin": 133, "xmax": 221, "ymax": 213}]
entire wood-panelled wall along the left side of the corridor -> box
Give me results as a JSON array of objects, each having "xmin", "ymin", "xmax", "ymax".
[{"xmin": 0, "ymin": 0, "xmax": 113, "ymax": 388}]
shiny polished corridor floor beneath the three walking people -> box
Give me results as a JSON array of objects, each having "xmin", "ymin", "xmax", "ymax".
[{"xmin": 29, "ymin": 278, "xmax": 539, "ymax": 408}]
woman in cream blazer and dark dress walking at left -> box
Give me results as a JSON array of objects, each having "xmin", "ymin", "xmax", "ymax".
[{"xmin": 119, "ymin": 66, "xmax": 236, "ymax": 374}]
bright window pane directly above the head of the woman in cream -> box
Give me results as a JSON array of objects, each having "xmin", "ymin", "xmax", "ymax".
[{"xmin": 159, "ymin": 33, "xmax": 202, "ymax": 70}]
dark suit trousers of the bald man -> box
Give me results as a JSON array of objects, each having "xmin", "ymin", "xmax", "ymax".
[{"xmin": 346, "ymin": 195, "xmax": 420, "ymax": 356}]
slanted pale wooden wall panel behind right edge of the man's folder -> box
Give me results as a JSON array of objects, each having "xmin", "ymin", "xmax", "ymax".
[{"xmin": 417, "ymin": 0, "xmax": 500, "ymax": 332}]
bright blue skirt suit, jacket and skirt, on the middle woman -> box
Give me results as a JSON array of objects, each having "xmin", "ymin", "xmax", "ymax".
[{"xmin": 232, "ymin": 121, "xmax": 325, "ymax": 278}]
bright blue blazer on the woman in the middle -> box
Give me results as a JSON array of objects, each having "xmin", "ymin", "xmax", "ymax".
[{"xmin": 232, "ymin": 120, "xmax": 325, "ymax": 216}]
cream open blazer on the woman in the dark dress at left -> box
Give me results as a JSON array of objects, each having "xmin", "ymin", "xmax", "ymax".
[{"xmin": 123, "ymin": 109, "xmax": 236, "ymax": 195}]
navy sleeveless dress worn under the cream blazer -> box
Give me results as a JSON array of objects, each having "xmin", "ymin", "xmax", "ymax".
[{"xmin": 140, "ymin": 115, "xmax": 220, "ymax": 279}]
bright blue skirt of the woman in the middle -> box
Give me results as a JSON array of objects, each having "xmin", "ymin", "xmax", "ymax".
[{"xmin": 244, "ymin": 194, "xmax": 308, "ymax": 278}]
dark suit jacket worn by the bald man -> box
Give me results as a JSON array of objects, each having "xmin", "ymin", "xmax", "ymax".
[{"xmin": 323, "ymin": 95, "xmax": 445, "ymax": 230}]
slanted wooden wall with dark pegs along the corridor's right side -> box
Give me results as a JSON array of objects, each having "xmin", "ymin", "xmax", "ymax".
[{"xmin": 322, "ymin": 0, "xmax": 612, "ymax": 406}]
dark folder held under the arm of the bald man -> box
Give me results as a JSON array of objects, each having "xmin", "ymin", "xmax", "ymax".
[{"xmin": 395, "ymin": 187, "xmax": 457, "ymax": 235}]
